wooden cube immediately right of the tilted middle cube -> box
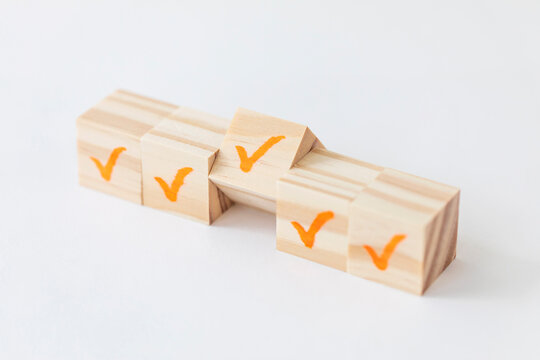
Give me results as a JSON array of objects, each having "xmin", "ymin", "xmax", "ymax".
[{"xmin": 276, "ymin": 149, "xmax": 383, "ymax": 271}]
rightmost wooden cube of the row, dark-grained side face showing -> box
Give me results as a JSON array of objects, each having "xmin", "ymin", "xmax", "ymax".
[{"xmin": 348, "ymin": 169, "xmax": 459, "ymax": 294}]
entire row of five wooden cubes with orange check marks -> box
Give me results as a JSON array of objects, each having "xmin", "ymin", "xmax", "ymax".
[{"xmin": 77, "ymin": 90, "xmax": 459, "ymax": 294}]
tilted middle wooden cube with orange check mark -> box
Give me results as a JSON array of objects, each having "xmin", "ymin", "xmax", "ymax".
[{"xmin": 210, "ymin": 108, "xmax": 322, "ymax": 213}]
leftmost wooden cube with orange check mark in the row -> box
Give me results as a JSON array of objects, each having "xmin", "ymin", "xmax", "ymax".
[{"xmin": 77, "ymin": 90, "xmax": 177, "ymax": 204}]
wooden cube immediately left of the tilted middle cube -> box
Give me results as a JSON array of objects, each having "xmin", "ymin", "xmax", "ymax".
[{"xmin": 141, "ymin": 107, "xmax": 232, "ymax": 224}]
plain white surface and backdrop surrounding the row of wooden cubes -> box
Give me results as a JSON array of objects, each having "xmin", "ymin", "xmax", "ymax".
[{"xmin": 0, "ymin": 0, "xmax": 540, "ymax": 360}]
